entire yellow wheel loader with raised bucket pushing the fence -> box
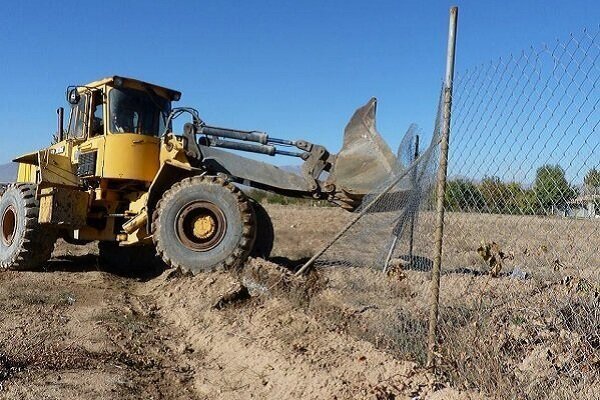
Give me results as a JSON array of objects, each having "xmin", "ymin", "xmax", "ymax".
[{"xmin": 0, "ymin": 76, "xmax": 396, "ymax": 273}]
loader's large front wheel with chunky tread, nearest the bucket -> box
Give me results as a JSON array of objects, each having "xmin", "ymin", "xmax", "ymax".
[{"xmin": 152, "ymin": 176, "xmax": 256, "ymax": 274}]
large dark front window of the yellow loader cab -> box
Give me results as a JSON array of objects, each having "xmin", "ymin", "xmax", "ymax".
[{"xmin": 109, "ymin": 88, "xmax": 171, "ymax": 136}]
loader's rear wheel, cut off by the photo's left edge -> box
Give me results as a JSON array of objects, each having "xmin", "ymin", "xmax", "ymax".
[{"xmin": 0, "ymin": 184, "xmax": 57, "ymax": 270}]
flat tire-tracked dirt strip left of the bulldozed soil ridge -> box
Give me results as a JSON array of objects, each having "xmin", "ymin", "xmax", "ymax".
[{"xmin": 0, "ymin": 243, "xmax": 202, "ymax": 400}]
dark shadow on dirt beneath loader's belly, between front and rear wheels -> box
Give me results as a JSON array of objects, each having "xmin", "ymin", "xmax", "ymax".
[{"xmin": 44, "ymin": 254, "xmax": 167, "ymax": 282}]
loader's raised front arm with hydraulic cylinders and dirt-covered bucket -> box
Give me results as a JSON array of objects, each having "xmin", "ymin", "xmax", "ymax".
[{"xmin": 165, "ymin": 98, "xmax": 397, "ymax": 211}]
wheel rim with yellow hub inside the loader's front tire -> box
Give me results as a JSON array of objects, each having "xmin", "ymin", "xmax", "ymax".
[{"xmin": 175, "ymin": 201, "xmax": 227, "ymax": 251}]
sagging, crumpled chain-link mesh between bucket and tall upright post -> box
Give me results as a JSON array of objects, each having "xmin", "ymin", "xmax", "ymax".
[{"xmin": 296, "ymin": 97, "xmax": 440, "ymax": 363}]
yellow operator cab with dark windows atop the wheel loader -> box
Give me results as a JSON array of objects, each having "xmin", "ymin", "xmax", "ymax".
[{"xmin": 64, "ymin": 76, "xmax": 181, "ymax": 185}]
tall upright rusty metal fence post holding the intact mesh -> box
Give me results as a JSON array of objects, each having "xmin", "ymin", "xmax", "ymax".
[{"xmin": 427, "ymin": 7, "xmax": 458, "ymax": 368}]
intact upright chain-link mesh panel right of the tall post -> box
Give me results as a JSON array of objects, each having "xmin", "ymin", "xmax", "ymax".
[{"xmin": 438, "ymin": 26, "xmax": 600, "ymax": 399}]
